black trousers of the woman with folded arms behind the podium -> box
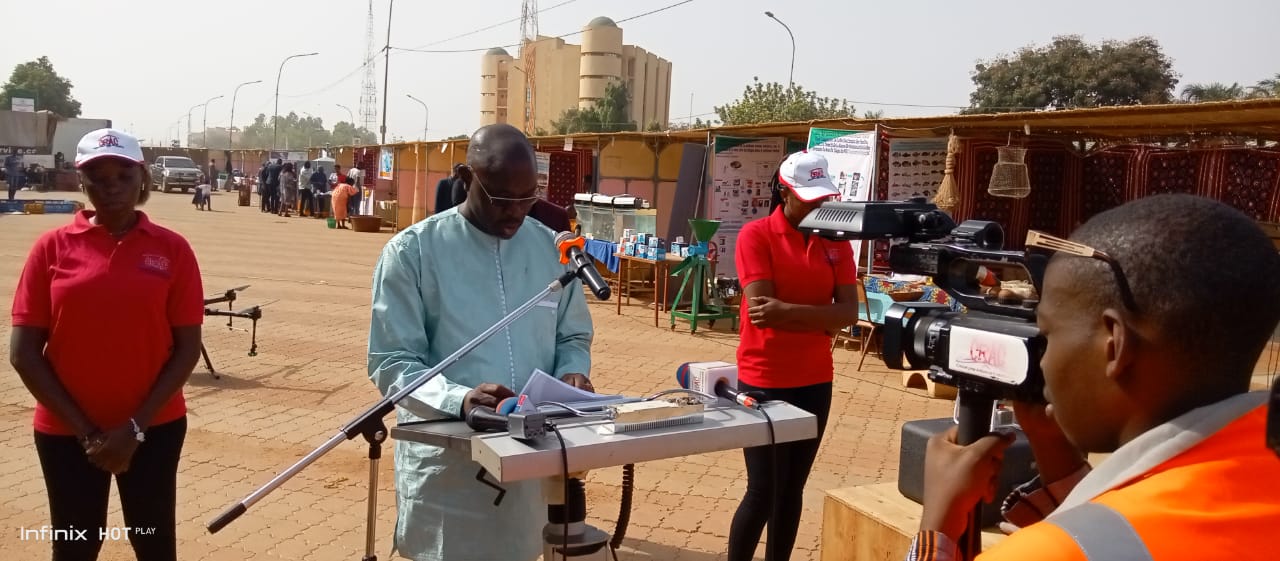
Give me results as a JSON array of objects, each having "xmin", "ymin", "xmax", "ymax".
[{"xmin": 728, "ymin": 382, "xmax": 831, "ymax": 561}]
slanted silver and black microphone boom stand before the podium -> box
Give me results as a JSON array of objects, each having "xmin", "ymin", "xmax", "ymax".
[{"xmin": 205, "ymin": 265, "xmax": 581, "ymax": 561}]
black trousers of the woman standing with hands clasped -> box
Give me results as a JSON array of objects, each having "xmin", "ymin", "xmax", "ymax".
[{"xmin": 36, "ymin": 418, "xmax": 187, "ymax": 561}]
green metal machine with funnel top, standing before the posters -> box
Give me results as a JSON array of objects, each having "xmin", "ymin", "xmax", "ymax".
[{"xmin": 671, "ymin": 218, "xmax": 737, "ymax": 333}]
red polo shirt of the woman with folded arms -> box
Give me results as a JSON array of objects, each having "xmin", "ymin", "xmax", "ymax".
[{"xmin": 735, "ymin": 207, "xmax": 858, "ymax": 388}]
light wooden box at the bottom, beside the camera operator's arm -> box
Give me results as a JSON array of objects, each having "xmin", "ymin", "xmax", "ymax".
[{"xmin": 820, "ymin": 483, "xmax": 1005, "ymax": 561}]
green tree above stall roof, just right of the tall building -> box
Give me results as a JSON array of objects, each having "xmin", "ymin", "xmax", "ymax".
[{"xmin": 716, "ymin": 78, "xmax": 855, "ymax": 124}]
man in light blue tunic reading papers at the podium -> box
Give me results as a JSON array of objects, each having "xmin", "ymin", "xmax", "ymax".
[{"xmin": 369, "ymin": 124, "xmax": 591, "ymax": 561}]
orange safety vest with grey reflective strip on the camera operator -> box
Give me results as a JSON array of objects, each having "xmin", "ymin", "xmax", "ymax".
[{"xmin": 977, "ymin": 405, "xmax": 1280, "ymax": 561}]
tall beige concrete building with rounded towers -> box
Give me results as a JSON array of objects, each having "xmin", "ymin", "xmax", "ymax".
[{"xmin": 480, "ymin": 17, "xmax": 671, "ymax": 133}]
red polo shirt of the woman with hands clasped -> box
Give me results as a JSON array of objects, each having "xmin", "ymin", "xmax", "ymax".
[{"xmin": 13, "ymin": 210, "xmax": 205, "ymax": 434}]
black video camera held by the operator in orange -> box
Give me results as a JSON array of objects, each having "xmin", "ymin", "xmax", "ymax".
[{"xmin": 800, "ymin": 199, "xmax": 1048, "ymax": 402}]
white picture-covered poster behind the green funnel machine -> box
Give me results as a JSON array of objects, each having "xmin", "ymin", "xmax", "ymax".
[{"xmin": 707, "ymin": 136, "xmax": 786, "ymax": 277}]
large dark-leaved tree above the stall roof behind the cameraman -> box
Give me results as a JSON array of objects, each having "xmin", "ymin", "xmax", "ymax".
[{"xmin": 961, "ymin": 35, "xmax": 1179, "ymax": 113}]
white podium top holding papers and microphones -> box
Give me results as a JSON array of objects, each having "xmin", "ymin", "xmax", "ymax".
[{"xmin": 390, "ymin": 400, "xmax": 818, "ymax": 483}]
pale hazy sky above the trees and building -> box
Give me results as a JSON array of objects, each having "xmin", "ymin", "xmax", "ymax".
[{"xmin": 0, "ymin": 0, "xmax": 1280, "ymax": 142}]
